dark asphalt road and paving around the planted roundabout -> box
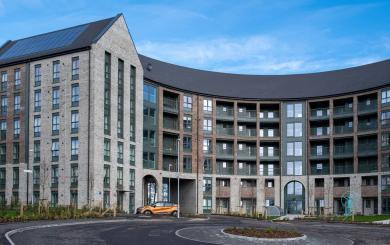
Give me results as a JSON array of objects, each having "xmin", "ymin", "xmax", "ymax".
[{"xmin": 0, "ymin": 216, "xmax": 390, "ymax": 245}]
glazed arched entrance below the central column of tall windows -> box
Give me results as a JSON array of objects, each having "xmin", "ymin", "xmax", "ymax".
[{"xmin": 284, "ymin": 181, "xmax": 305, "ymax": 214}]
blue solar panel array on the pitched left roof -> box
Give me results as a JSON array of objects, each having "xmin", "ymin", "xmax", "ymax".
[{"xmin": 0, "ymin": 24, "xmax": 88, "ymax": 60}]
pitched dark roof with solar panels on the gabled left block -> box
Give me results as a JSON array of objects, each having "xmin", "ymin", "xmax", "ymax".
[{"xmin": 0, "ymin": 14, "xmax": 121, "ymax": 66}]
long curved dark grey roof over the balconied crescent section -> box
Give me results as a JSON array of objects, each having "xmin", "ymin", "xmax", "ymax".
[{"xmin": 139, "ymin": 55, "xmax": 390, "ymax": 100}]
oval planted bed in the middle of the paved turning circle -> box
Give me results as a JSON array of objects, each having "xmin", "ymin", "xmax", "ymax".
[{"xmin": 223, "ymin": 227, "xmax": 303, "ymax": 239}]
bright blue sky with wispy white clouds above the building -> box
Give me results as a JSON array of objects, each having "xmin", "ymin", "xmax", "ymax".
[{"xmin": 0, "ymin": 0, "xmax": 390, "ymax": 74}]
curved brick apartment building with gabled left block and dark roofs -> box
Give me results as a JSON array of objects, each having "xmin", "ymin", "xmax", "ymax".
[{"xmin": 0, "ymin": 15, "xmax": 390, "ymax": 214}]
